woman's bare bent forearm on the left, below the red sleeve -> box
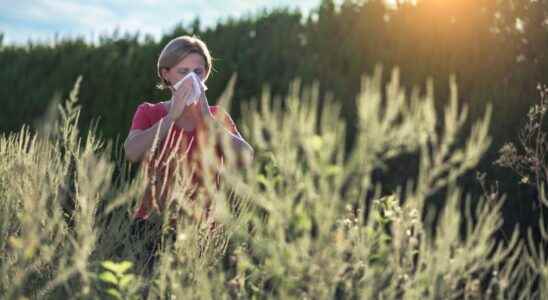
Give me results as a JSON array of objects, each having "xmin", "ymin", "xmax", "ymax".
[{"xmin": 124, "ymin": 116, "xmax": 173, "ymax": 162}]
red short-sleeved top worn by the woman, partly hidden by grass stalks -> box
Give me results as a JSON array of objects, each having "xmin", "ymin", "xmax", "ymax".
[{"xmin": 131, "ymin": 102, "xmax": 240, "ymax": 220}]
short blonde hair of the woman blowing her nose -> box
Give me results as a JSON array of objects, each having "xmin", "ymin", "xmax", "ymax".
[{"xmin": 157, "ymin": 35, "xmax": 212, "ymax": 89}]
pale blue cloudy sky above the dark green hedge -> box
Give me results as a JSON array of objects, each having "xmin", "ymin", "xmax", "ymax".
[{"xmin": 0, "ymin": 0, "xmax": 320, "ymax": 44}]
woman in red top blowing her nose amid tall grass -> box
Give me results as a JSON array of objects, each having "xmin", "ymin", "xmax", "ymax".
[{"xmin": 124, "ymin": 36, "xmax": 253, "ymax": 220}]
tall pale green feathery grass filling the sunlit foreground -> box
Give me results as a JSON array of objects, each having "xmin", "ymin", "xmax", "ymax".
[{"xmin": 0, "ymin": 70, "xmax": 548, "ymax": 299}]
